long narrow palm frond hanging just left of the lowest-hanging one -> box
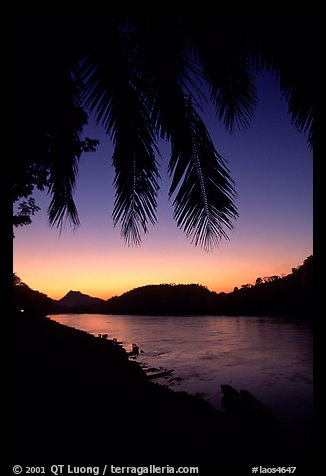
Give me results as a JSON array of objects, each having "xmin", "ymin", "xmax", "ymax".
[{"xmin": 79, "ymin": 20, "xmax": 159, "ymax": 245}]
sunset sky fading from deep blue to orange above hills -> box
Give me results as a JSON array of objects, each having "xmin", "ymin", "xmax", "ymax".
[{"xmin": 13, "ymin": 73, "xmax": 313, "ymax": 299}]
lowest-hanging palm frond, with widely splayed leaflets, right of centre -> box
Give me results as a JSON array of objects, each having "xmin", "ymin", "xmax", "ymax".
[{"xmin": 121, "ymin": 18, "xmax": 237, "ymax": 250}]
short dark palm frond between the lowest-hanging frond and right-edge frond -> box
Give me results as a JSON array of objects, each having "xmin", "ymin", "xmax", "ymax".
[{"xmin": 185, "ymin": 14, "xmax": 257, "ymax": 132}]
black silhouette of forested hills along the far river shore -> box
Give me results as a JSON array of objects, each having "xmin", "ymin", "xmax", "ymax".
[{"xmin": 52, "ymin": 256, "xmax": 313, "ymax": 319}]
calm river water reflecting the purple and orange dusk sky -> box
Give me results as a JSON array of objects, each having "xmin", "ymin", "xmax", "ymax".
[{"xmin": 50, "ymin": 314, "xmax": 313, "ymax": 443}]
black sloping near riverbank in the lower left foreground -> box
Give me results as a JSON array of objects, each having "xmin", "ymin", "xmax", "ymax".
[{"xmin": 13, "ymin": 315, "xmax": 306, "ymax": 465}]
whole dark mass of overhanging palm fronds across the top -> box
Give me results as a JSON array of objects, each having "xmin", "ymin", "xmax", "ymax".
[{"xmin": 14, "ymin": 13, "xmax": 312, "ymax": 249}]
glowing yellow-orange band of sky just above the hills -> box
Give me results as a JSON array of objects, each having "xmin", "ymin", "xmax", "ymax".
[{"xmin": 14, "ymin": 238, "xmax": 309, "ymax": 299}]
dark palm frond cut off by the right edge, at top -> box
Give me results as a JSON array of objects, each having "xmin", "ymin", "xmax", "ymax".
[{"xmin": 251, "ymin": 12, "xmax": 313, "ymax": 147}]
